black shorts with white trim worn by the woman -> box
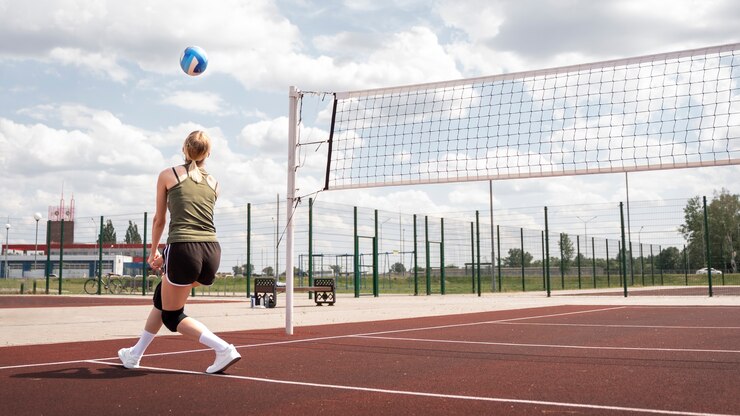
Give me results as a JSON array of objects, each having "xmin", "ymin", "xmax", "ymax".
[{"xmin": 163, "ymin": 242, "xmax": 221, "ymax": 286}]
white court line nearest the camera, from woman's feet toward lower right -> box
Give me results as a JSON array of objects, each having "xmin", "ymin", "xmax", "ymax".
[{"xmin": 86, "ymin": 360, "xmax": 738, "ymax": 416}]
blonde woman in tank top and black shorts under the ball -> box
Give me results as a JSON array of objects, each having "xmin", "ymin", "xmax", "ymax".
[{"xmin": 118, "ymin": 131, "xmax": 241, "ymax": 373}]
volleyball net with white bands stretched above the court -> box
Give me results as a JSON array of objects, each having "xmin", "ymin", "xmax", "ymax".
[{"xmin": 324, "ymin": 44, "xmax": 740, "ymax": 189}]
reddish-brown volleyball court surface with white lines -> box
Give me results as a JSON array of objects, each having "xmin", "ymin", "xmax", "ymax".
[{"xmin": 0, "ymin": 306, "xmax": 740, "ymax": 416}]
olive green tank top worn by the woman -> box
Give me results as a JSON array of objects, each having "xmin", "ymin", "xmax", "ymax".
[{"xmin": 167, "ymin": 168, "xmax": 218, "ymax": 244}]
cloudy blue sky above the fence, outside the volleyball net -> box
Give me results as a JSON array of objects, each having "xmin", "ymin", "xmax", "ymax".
[{"xmin": 0, "ymin": 0, "xmax": 740, "ymax": 244}]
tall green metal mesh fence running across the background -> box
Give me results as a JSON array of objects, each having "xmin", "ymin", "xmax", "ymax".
[{"xmin": 0, "ymin": 193, "xmax": 740, "ymax": 296}]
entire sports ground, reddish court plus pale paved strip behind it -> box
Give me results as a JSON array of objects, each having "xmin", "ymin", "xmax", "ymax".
[{"xmin": 0, "ymin": 292, "xmax": 740, "ymax": 415}]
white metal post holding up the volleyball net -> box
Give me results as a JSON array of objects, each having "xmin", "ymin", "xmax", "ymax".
[{"xmin": 285, "ymin": 86, "xmax": 301, "ymax": 335}]
